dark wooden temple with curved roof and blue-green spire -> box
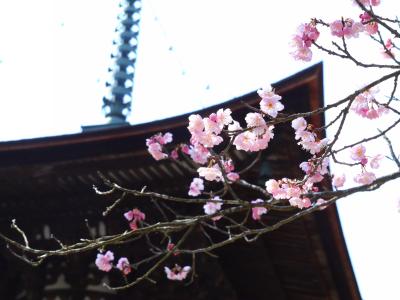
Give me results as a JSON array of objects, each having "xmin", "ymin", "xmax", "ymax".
[{"xmin": 0, "ymin": 0, "xmax": 361, "ymax": 300}]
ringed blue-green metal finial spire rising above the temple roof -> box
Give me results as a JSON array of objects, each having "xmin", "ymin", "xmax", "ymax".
[{"xmin": 103, "ymin": 0, "xmax": 141, "ymax": 125}]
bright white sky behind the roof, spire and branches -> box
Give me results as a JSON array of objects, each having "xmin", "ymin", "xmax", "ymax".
[{"xmin": 0, "ymin": 0, "xmax": 400, "ymax": 300}]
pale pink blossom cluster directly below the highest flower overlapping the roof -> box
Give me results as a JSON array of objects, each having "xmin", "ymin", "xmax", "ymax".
[{"xmin": 233, "ymin": 113, "xmax": 274, "ymax": 152}]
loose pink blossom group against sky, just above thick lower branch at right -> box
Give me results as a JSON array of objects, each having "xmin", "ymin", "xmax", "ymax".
[{"xmin": 350, "ymin": 144, "xmax": 383, "ymax": 184}]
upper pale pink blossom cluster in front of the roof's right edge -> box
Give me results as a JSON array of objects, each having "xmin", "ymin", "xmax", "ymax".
[{"xmin": 292, "ymin": 117, "xmax": 328, "ymax": 154}]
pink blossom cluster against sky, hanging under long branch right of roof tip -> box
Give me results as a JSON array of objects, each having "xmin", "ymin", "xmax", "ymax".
[{"xmin": 351, "ymin": 88, "xmax": 389, "ymax": 120}]
